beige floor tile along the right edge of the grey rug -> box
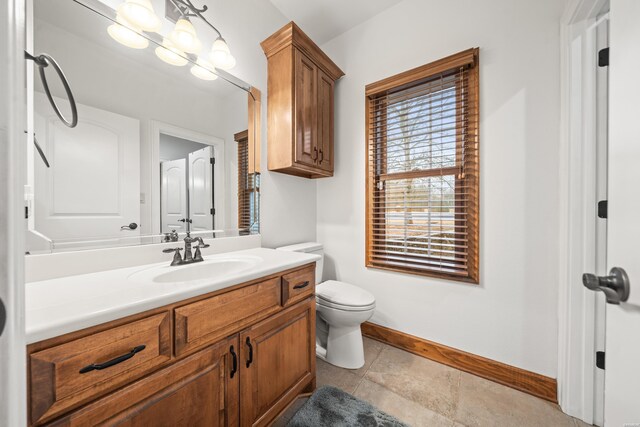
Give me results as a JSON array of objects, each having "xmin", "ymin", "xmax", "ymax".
[{"xmin": 355, "ymin": 379, "xmax": 454, "ymax": 427}]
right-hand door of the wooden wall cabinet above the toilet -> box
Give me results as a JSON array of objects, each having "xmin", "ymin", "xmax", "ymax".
[{"xmin": 317, "ymin": 68, "xmax": 334, "ymax": 172}]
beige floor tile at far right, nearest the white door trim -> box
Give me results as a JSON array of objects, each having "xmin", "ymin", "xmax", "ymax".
[{"xmin": 454, "ymin": 372, "xmax": 575, "ymax": 427}]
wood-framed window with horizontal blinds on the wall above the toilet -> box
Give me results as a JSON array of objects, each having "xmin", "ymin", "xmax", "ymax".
[{"xmin": 366, "ymin": 49, "xmax": 479, "ymax": 283}]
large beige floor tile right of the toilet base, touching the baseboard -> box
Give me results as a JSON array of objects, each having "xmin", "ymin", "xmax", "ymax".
[{"xmin": 365, "ymin": 346, "xmax": 460, "ymax": 418}]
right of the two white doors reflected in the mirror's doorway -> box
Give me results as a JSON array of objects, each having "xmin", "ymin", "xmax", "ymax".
[{"xmin": 189, "ymin": 147, "xmax": 214, "ymax": 231}]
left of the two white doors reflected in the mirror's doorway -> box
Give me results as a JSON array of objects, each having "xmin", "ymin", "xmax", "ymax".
[{"xmin": 160, "ymin": 159, "xmax": 187, "ymax": 233}]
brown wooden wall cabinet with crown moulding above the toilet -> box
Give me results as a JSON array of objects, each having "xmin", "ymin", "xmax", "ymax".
[{"xmin": 261, "ymin": 22, "xmax": 344, "ymax": 178}]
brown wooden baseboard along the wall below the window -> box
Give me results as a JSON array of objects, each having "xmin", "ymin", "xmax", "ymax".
[{"xmin": 362, "ymin": 322, "xmax": 558, "ymax": 403}]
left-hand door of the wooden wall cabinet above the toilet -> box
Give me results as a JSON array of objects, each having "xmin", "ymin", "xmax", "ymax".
[{"xmin": 294, "ymin": 50, "xmax": 318, "ymax": 166}]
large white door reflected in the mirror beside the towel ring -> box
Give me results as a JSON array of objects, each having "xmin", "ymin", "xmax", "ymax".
[{"xmin": 33, "ymin": 93, "xmax": 140, "ymax": 241}]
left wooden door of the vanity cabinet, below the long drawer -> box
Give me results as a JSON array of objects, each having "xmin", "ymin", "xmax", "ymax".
[{"xmin": 50, "ymin": 335, "xmax": 239, "ymax": 427}]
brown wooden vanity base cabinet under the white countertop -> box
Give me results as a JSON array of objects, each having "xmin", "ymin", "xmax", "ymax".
[{"xmin": 27, "ymin": 264, "xmax": 316, "ymax": 427}]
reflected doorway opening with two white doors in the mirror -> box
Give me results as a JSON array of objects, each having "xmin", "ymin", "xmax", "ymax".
[{"xmin": 160, "ymin": 134, "xmax": 215, "ymax": 233}]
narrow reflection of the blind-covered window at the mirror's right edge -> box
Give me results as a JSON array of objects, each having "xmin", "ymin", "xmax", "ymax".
[{"xmin": 234, "ymin": 130, "xmax": 260, "ymax": 234}]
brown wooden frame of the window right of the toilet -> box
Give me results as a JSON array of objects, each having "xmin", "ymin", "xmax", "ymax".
[{"xmin": 365, "ymin": 48, "xmax": 480, "ymax": 284}]
